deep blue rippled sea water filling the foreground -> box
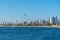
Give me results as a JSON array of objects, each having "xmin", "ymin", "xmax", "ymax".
[{"xmin": 0, "ymin": 27, "xmax": 60, "ymax": 40}]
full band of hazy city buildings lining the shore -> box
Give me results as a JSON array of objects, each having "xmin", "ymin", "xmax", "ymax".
[{"xmin": 0, "ymin": 16, "xmax": 60, "ymax": 26}]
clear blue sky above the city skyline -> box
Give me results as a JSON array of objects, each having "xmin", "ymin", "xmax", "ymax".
[{"xmin": 0, "ymin": 0, "xmax": 60, "ymax": 21}]
